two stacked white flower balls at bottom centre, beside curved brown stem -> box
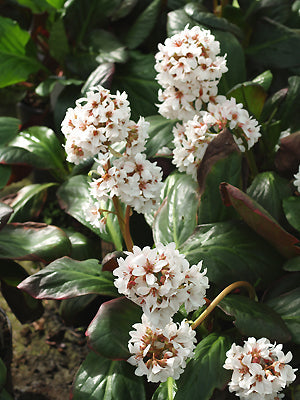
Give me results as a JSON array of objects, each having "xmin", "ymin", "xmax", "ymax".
[{"xmin": 113, "ymin": 243, "xmax": 209, "ymax": 382}]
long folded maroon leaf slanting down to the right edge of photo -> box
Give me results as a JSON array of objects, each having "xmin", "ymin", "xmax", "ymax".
[{"xmin": 220, "ymin": 183, "xmax": 300, "ymax": 258}]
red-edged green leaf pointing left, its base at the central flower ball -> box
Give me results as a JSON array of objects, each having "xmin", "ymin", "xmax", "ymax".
[{"xmin": 18, "ymin": 257, "xmax": 118, "ymax": 300}]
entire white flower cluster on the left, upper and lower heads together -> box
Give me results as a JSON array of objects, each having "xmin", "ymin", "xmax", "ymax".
[{"xmin": 62, "ymin": 86, "xmax": 162, "ymax": 220}]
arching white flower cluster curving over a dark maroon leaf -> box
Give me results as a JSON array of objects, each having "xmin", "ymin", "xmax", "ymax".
[{"xmin": 173, "ymin": 96, "xmax": 261, "ymax": 179}]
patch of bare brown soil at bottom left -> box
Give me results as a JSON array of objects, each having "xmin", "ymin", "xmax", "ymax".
[{"xmin": 0, "ymin": 298, "xmax": 89, "ymax": 400}]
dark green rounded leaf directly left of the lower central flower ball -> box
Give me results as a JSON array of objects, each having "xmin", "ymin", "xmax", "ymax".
[{"xmin": 86, "ymin": 297, "xmax": 142, "ymax": 360}]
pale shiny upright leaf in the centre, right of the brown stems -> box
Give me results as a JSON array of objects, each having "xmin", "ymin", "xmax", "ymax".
[{"xmin": 153, "ymin": 173, "xmax": 199, "ymax": 247}]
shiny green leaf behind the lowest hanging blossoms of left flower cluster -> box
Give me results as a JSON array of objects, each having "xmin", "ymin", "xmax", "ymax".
[{"xmin": 57, "ymin": 175, "xmax": 122, "ymax": 250}]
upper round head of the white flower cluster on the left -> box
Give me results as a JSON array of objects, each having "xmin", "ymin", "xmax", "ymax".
[{"xmin": 61, "ymin": 85, "xmax": 130, "ymax": 164}]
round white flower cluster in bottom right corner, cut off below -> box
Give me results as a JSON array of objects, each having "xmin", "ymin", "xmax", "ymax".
[{"xmin": 223, "ymin": 337, "xmax": 296, "ymax": 400}]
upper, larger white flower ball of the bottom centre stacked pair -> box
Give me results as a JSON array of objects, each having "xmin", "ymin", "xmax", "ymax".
[{"xmin": 113, "ymin": 243, "xmax": 209, "ymax": 326}]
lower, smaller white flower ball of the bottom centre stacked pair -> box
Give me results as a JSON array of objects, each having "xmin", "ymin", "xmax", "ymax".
[{"xmin": 127, "ymin": 315, "xmax": 196, "ymax": 382}]
